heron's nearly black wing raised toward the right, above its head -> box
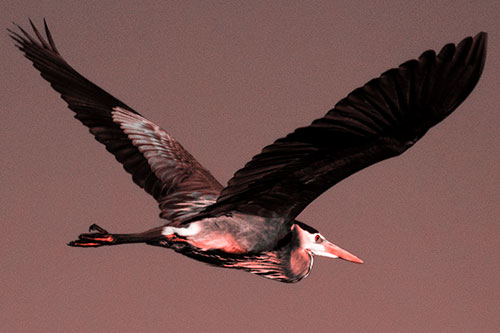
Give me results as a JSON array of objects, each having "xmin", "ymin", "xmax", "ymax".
[{"xmin": 204, "ymin": 32, "xmax": 487, "ymax": 221}]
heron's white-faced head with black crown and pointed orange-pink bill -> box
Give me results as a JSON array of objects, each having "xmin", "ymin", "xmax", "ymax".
[{"xmin": 294, "ymin": 221, "xmax": 363, "ymax": 264}]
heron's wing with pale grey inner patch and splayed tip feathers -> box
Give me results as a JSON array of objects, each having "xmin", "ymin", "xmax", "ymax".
[{"xmin": 9, "ymin": 20, "xmax": 222, "ymax": 222}]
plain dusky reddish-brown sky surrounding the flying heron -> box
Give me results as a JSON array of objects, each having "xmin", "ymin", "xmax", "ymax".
[{"xmin": 0, "ymin": 0, "xmax": 500, "ymax": 332}]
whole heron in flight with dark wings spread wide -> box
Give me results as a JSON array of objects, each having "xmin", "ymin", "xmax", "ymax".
[{"xmin": 7, "ymin": 19, "xmax": 487, "ymax": 283}]
